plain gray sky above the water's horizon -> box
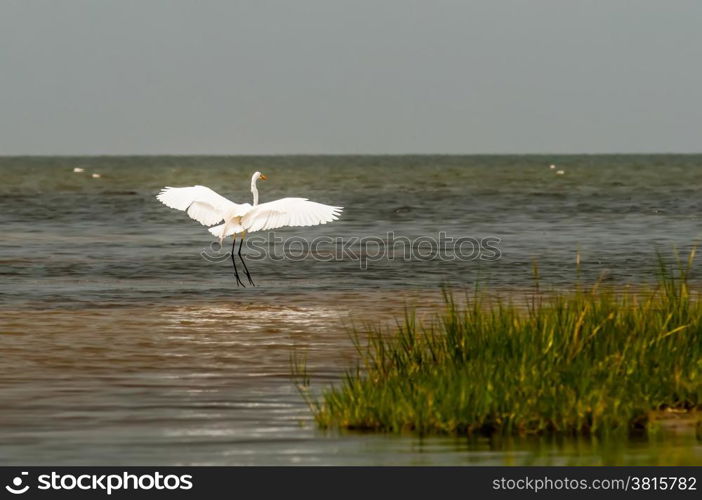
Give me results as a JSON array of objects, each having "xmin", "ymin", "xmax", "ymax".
[{"xmin": 0, "ymin": 0, "xmax": 702, "ymax": 155}]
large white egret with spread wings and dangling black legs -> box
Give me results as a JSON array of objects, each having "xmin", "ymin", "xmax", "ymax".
[{"xmin": 156, "ymin": 172, "xmax": 343, "ymax": 286}]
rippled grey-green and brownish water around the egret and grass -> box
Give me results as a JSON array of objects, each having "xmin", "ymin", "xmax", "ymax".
[{"xmin": 0, "ymin": 155, "xmax": 702, "ymax": 464}]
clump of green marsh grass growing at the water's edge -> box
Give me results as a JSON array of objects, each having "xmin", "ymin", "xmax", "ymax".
[{"xmin": 296, "ymin": 251, "xmax": 702, "ymax": 435}]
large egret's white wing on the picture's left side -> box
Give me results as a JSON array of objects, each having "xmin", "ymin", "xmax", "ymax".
[{"xmin": 156, "ymin": 186, "xmax": 251, "ymax": 226}]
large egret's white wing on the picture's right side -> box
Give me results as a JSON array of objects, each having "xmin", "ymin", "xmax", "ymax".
[{"xmin": 241, "ymin": 198, "xmax": 343, "ymax": 233}]
